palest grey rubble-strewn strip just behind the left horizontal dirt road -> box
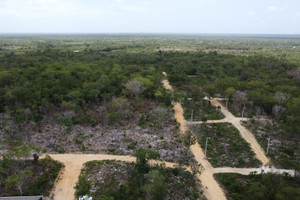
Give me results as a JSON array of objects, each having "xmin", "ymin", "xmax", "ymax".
[{"xmin": 30, "ymin": 122, "xmax": 184, "ymax": 160}]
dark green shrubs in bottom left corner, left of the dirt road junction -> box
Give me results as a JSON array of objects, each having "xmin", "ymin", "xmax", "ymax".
[{"xmin": 0, "ymin": 145, "xmax": 63, "ymax": 197}]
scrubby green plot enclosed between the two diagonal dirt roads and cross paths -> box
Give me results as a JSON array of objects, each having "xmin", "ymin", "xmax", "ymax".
[{"xmin": 191, "ymin": 123, "xmax": 260, "ymax": 167}]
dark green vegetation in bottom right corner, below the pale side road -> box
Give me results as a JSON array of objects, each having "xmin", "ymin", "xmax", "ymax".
[{"xmin": 214, "ymin": 173, "xmax": 300, "ymax": 200}]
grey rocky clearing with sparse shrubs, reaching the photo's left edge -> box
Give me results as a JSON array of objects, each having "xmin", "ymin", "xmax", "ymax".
[{"xmin": 0, "ymin": 104, "xmax": 187, "ymax": 162}]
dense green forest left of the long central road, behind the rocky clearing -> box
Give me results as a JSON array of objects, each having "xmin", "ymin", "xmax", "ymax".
[{"xmin": 0, "ymin": 42, "xmax": 170, "ymax": 122}]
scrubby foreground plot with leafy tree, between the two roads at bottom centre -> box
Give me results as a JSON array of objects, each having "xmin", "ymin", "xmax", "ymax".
[{"xmin": 75, "ymin": 149, "xmax": 204, "ymax": 200}]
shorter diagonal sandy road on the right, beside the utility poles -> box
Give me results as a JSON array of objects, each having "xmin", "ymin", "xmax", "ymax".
[{"xmin": 210, "ymin": 99, "xmax": 270, "ymax": 165}]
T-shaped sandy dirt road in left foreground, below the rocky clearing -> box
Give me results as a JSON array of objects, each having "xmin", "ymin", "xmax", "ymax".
[{"xmin": 41, "ymin": 154, "xmax": 176, "ymax": 200}]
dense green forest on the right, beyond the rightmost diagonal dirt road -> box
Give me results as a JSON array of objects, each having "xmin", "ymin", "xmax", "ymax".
[{"xmin": 164, "ymin": 52, "xmax": 300, "ymax": 134}]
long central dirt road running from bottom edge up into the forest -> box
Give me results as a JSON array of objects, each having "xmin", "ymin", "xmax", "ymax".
[{"xmin": 162, "ymin": 72, "xmax": 226, "ymax": 200}]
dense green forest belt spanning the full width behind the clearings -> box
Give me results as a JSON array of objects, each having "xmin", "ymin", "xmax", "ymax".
[{"xmin": 0, "ymin": 36, "xmax": 300, "ymax": 134}]
